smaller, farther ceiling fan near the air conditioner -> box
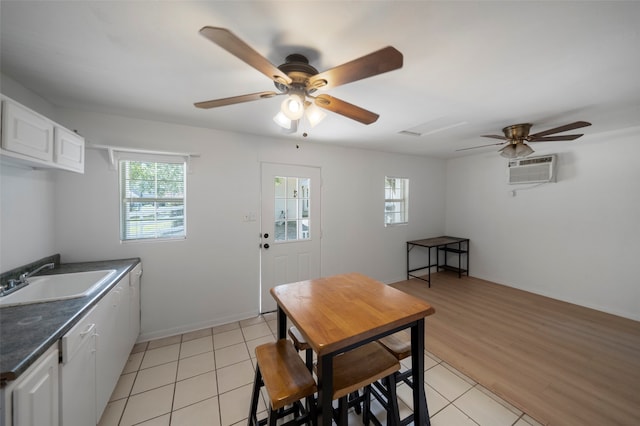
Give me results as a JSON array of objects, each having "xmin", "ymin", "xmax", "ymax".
[{"xmin": 456, "ymin": 121, "xmax": 591, "ymax": 158}]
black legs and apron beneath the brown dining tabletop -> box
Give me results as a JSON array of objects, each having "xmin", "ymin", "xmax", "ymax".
[{"xmin": 278, "ymin": 305, "xmax": 431, "ymax": 426}]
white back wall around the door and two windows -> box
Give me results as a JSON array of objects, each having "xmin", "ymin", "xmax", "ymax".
[{"xmin": 48, "ymin": 109, "xmax": 445, "ymax": 338}]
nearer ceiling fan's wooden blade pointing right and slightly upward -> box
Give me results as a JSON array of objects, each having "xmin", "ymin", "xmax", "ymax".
[{"xmin": 307, "ymin": 46, "xmax": 402, "ymax": 89}]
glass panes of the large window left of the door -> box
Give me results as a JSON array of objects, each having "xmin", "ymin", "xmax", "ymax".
[{"xmin": 119, "ymin": 160, "xmax": 186, "ymax": 241}]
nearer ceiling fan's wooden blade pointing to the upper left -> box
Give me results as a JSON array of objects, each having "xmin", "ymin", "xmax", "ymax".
[{"xmin": 200, "ymin": 26, "xmax": 291, "ymax": 85}]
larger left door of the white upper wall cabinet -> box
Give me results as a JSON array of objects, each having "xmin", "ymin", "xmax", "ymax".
[{"xmin": 2, "ymin": 101, "xmax": 53, "ymax": 162}]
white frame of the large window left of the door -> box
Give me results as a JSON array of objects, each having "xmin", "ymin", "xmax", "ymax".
[{"xmin": 116, "ymin": 152, "xmax": 188, "ymax": 243}]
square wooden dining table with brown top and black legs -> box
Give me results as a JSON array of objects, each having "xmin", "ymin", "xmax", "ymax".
[{"xmin": 271, "ymin": 273, "xmax": 435, "ymax": 426}]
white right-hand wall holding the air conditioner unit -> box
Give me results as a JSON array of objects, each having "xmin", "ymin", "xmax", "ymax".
[{"xmin": 446, "ymin": 129, "xmax": 640, "ymax": 320}]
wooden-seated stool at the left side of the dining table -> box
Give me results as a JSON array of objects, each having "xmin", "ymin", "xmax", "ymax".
[{"xmin": 248, "ymin": 339, "xmax": 317, "ymax": 426}]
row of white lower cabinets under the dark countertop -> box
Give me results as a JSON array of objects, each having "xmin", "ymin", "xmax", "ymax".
[{"xmin": 0, "ymin": 264, "xmax": 142, "ymax": 426}]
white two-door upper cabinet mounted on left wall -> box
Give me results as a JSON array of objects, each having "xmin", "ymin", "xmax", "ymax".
[{"xmin": 0, "ymin": 96, "xmax": 84, "ymax": 173}]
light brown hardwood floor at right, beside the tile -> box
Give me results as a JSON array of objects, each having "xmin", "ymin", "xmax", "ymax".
[{"xmin": 392, "ymin": 272, "xmax": 640, "ymax": 426}]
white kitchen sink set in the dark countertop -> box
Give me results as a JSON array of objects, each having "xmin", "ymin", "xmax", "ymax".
[{"xmin": 0, "ymin": 269, "xmax": 116, "ymax": 307}]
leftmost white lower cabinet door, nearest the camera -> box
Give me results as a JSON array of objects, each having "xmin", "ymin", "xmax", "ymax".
[{"xmin": 13, "ymin": 349, "xmax": 58, "ymax": 426}]
